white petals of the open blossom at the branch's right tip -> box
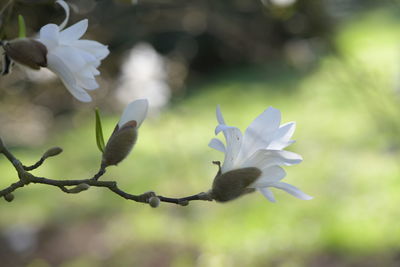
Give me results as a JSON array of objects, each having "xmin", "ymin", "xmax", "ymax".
[{"xmin": 209, "ymin": 106, "xmax": 312, "ymax": 202}]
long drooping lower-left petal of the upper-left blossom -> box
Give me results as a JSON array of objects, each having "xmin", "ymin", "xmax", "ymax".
[{"xmin": 47, "ymin": 53, "xmax": 92, "ymax": 102}]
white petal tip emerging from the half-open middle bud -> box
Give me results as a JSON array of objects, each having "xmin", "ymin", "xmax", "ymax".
[{"xmin": 118, "ymin": 99, "xmax": 149, "ymax": 128}]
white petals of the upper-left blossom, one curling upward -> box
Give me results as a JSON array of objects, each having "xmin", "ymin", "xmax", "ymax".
[{"xmin": 37, "ymin": 0, "xmax": 109, "ymax": 102}]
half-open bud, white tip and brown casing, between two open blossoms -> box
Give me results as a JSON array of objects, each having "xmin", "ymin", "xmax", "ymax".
[{"xmin": 102, "ymin": 99, "xmax": 149, "ymax": 167}]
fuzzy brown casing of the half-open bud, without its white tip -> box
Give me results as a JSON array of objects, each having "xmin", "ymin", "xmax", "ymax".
[{"xmin": 102, "ymin": 121, "xmax": 138, "ymax": 167}]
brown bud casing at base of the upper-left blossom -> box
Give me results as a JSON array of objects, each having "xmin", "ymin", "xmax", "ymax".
[{"xmin": 3, "ymin": 38, "xmax": 47, "ymax": 70}]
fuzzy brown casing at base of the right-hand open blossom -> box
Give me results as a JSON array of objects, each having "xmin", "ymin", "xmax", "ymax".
[{"xmin": 211, "ymin": 167, "xmax": 261, "ymax": 202}]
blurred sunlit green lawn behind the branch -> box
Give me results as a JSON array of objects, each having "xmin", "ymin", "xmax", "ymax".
[{"xmin": 0, "ymin": 4, "xmax": 400, "ymax": 267}]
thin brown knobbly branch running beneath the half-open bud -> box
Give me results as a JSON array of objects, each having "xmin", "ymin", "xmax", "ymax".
[{"xmin": 0, "ymin": 139, "xmax": 212, "ymax": 207}]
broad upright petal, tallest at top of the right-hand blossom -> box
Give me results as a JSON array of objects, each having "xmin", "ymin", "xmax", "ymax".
[{"xmin": 239, "ymin": 107, "xmax": 281, "ymax": 162}]
